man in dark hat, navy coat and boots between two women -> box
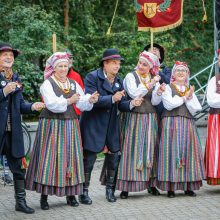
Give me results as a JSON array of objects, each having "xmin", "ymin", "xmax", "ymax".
[{"xmin": 79, "ymin": 49, "xmax": 142, "ymax": 205}]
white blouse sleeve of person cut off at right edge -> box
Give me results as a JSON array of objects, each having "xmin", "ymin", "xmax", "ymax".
[{"xmin": 207, "ymin": 76, "xmax": 220, "ymax": 108}]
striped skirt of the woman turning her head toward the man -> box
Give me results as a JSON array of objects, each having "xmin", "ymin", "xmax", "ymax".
[{"xmin": 116, "ymin": 112, "xmax": 158, "ymax": 192}]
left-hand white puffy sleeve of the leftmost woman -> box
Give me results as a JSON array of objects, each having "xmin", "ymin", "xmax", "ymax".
[{"xmin": 40, "ymin": 80, "xmax": 67, "ymax": 113}]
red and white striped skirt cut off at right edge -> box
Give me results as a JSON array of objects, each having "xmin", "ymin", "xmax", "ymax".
[{"xmin": 205, "ymin": 114, "xmax": 220, "ymax": 185}]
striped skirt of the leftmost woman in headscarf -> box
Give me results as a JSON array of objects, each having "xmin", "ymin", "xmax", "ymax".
[{"xmin": 26, "ymin": 119, "xmax": 84, "ymax": 196}]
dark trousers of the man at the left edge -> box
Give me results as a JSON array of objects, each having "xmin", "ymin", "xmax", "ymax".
[{"xmin": 2, "ymin": 132, "xmax": 25, "ymax": 180}]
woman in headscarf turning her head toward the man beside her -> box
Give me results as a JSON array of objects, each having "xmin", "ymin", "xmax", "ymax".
[{"xmin": 116, "ymin": 51, "xmax": 163, "ymax": 199}]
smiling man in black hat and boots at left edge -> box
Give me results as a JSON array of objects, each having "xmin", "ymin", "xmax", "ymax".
[{"xmin": 0, "ymin": 43, "xmax": 44, "ymax": 214}]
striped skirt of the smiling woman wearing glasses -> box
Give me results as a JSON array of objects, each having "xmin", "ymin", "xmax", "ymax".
[{"xmin": 158, "ymin": 117, "xmax": 204, "ymax": 191}]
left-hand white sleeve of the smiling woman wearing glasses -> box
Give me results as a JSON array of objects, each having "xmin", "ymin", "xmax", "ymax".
[{"xmin": 162, "ymin": 85, "xmax": 184, "ymax": 111}]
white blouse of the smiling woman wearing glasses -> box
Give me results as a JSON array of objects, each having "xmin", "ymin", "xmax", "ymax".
[{"xmin": 162, "ymin": 85, "xmax": 202, "ymax": 115}]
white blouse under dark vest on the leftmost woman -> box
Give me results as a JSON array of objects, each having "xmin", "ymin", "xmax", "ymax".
[{"xmin": 40, "ymin": 77, "xmax": 93, "ymax": 113}]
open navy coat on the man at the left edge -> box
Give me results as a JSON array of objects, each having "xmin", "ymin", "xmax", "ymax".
[{"xmin": 0, "ymin": 73, "xmax": 32, "ymax": 158}]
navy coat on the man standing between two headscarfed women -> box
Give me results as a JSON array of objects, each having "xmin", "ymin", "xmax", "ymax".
[{"xmin": 80, "ymin": 68, "xmax": 130, "ymax": 153}]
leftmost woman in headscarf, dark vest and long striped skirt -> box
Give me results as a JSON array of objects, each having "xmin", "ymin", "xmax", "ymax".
[{"xmin": 26, "ymin": 52, "xmax": 99, "ymax": 210}]
